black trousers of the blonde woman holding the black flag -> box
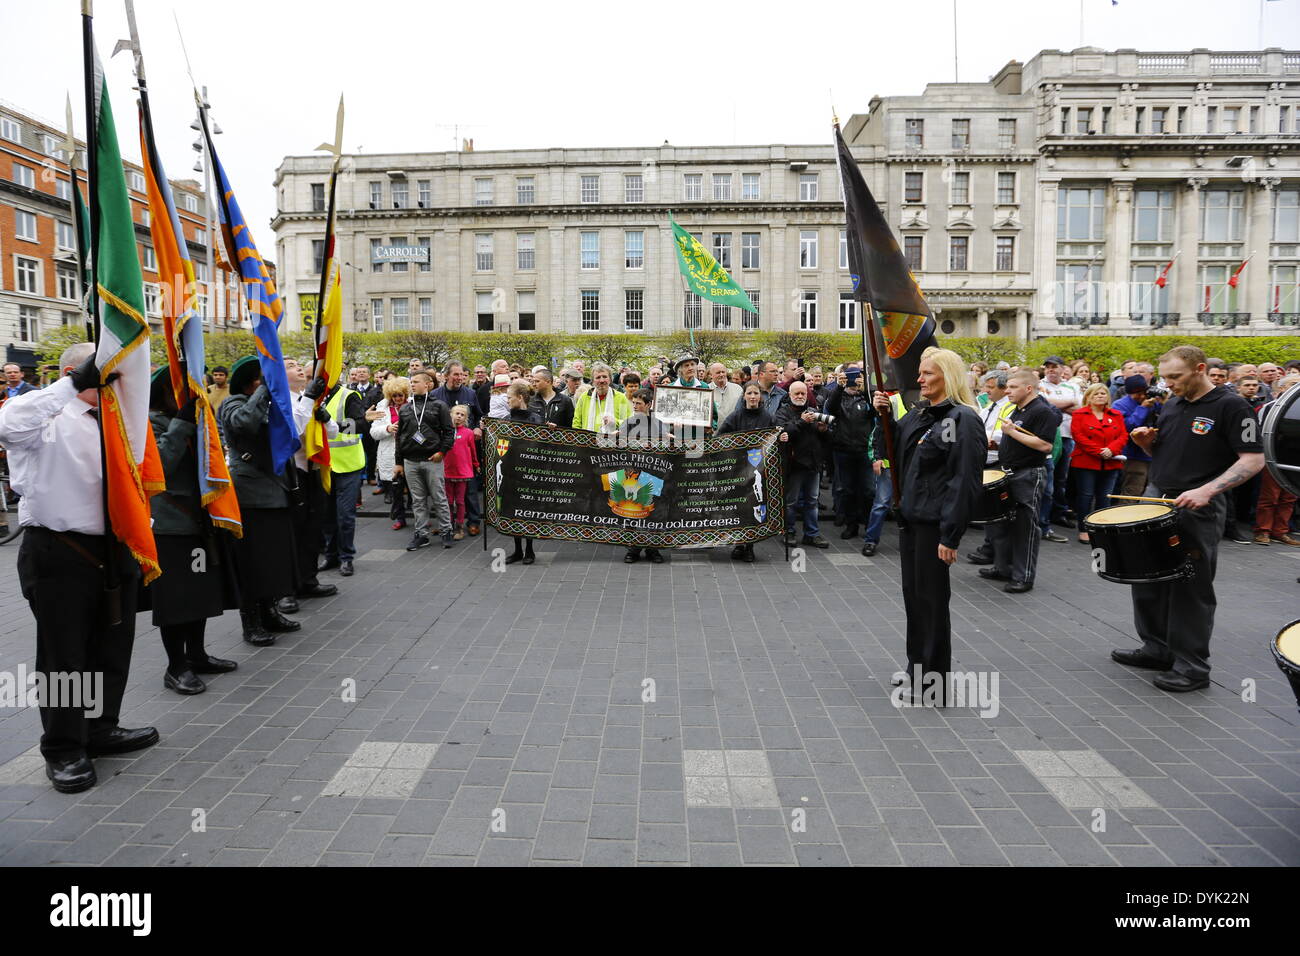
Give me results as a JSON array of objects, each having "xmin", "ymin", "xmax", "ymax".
[{"xmin": 898, "ymin": 524, "xmax": 953, "ymax": 700}]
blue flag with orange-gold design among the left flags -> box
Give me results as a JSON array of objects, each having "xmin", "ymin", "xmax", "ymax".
[{"xmin": 203, "ymin": 124, "xmax": 299, "ymax": 473}]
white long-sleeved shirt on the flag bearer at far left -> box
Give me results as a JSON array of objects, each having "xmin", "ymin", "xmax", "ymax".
[{"xmin": 0, "ymin": 376, "xmax": 104, "ymax": 535}]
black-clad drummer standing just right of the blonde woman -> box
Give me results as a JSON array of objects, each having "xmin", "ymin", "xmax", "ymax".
[{"xmin": 979, "ymin": 368, "xmax": 1061, "ymax": 594}]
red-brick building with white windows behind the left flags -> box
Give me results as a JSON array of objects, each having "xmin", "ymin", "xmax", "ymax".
[{"xmin": 0, "ymin": 104, "xmax": 241, "ymax": 369}]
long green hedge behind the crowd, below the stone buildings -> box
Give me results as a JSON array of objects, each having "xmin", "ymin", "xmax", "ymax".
[{"xmin": 36, "ymin": 326, "xmax": 1300, "ymax": 371}]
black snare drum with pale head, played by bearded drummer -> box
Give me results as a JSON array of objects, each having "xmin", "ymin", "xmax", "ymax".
[{"xmin": 1083, "ymin": 505, "xmax": 1192, "ymax": 584}]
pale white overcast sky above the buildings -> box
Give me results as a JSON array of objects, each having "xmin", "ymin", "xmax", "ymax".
[{"xmin": 0, "ymin": 0, "xmax": 1300, "ymax": 238}]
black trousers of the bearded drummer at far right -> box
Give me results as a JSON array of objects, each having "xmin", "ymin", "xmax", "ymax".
[{"xmin": 1132, "ymin": 490, "xmax": 1227, "ymax": 679}]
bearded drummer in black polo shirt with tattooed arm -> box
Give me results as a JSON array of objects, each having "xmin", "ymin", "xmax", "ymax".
[{"xmin": 1110, "ymin": 345, "xmax": 1264, "ymax": 692}]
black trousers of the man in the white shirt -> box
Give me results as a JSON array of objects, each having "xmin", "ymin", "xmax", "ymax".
[{"xmin": 18, "ymin": 527, "xmax": 140, "ymax": 760}]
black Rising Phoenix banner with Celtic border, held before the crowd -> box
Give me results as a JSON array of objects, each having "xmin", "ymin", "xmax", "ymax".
[{"xmin": 484, "ymin": 419, "xmax": 785, "ymax": 548}]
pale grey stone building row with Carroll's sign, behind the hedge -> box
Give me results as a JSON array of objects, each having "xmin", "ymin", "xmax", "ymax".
[{"xmin": 273, "ymin": 48, "xmax": 1300, "ymax": 338}]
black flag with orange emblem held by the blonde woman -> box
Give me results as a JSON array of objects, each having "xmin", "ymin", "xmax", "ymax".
[{"xmin": 835, "ymin": 124, "xmax": 937, "ymax": 403}]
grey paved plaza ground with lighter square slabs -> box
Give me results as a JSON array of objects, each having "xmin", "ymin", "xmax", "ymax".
[{"xmin": 0, "ymin": 518, "xmax": 1300, "ymax": 866}]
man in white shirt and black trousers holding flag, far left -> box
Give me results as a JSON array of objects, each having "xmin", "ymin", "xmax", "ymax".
[{"xmin": 0, "ymin": 342, "xmax": 159, "ymax": 793}]
